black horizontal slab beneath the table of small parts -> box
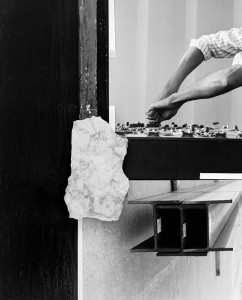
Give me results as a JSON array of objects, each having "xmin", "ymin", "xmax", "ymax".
[{"xmin": 123, "ymin": 137, "xmax": 242, "ymax": 179}]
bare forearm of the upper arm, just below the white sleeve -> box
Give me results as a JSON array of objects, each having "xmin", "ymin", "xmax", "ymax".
[{"xmin": 166, "ymin": 47, "xmax": 204, "ymax": 92}]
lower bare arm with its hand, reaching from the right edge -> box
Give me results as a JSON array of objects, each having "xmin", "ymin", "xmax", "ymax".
[{"xmin": 148, "ymin": 65, "xmax": 242, "ymax": 122}]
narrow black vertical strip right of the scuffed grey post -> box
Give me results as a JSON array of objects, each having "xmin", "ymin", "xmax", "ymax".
[{"xmin": 97, "ymin": 0, "xmax": 109, "ymax": 122}]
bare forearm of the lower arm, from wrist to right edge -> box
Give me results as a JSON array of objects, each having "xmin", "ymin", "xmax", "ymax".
[{"xmin": 172, "ymin": 65, "xmax": 242, "ymax": 104}]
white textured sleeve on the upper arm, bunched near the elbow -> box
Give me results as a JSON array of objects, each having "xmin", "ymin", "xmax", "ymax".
[{"xmin": 190, "ymin": 27, "xmax": 242, "ymax": 60}]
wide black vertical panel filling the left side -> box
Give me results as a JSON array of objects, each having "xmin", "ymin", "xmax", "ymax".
[{"xmin": 0, "ymin": 0, "xmax": 79, "ymax": 300}]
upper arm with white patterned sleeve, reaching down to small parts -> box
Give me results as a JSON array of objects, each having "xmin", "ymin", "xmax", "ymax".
[{"xmin": 146, "ymin": 27, "xmax": 242, "ymax": 122}]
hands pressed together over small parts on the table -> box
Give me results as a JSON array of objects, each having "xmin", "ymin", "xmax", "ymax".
[{"xmin": 146, "ymin": 94, "xmax": 181, "ymax": 123}]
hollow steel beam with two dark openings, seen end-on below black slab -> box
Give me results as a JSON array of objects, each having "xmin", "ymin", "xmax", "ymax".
[{"xmin": 131, "ymin": 181, "xmax": 242, "ymax": 256}]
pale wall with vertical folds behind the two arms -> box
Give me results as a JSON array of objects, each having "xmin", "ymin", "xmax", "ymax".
[{"xmin": 110, "ymin": 0, "xmax": 242, "ymax": 126}]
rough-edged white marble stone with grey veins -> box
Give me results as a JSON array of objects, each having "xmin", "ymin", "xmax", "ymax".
[{"xmin": 64, "ymin": 116, "xmax": 129, "ymax": 221}]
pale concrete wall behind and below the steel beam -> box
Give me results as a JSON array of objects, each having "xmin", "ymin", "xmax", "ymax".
[{"xmin": 79, "ymin": 181, "xmax": 242, "ymax": 300}]
